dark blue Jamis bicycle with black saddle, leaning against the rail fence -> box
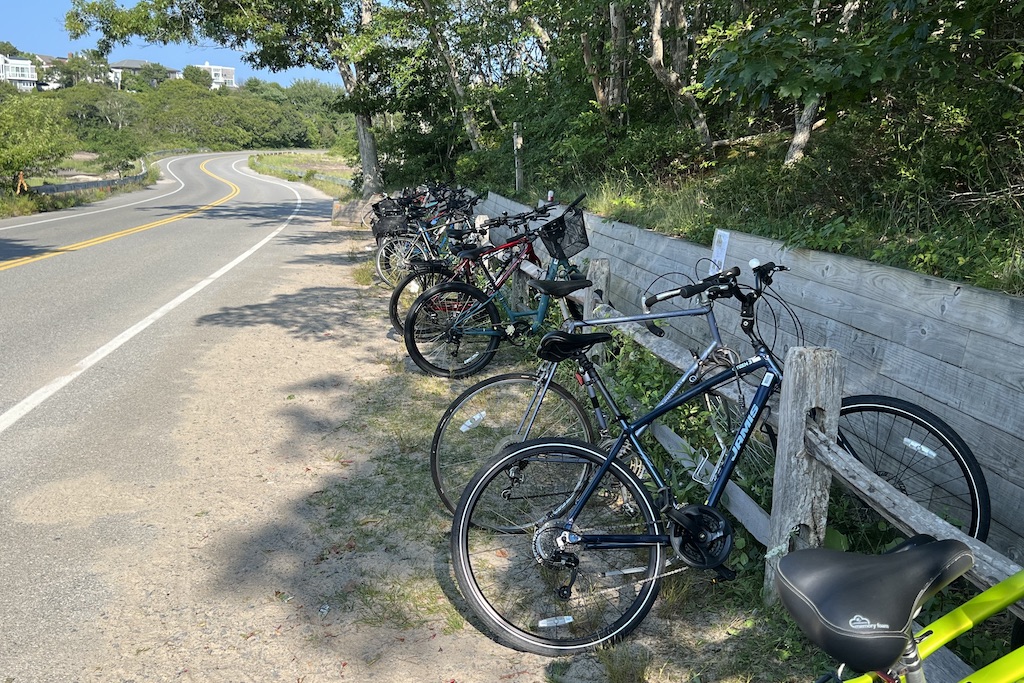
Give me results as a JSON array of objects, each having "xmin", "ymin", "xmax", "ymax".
[{"xmin": 451, "ymin": 263, "xmax": 987, "ymax": 655}]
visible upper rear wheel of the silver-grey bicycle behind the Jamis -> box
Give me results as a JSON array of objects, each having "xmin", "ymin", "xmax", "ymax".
[{"xmin": 430, "ymin": 373, "xmax": 597, "ymax": 512}]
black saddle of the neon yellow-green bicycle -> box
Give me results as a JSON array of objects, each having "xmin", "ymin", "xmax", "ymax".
[{"xmin": 775, "ymin": 541, "xmax": 974, "ymax": 672}]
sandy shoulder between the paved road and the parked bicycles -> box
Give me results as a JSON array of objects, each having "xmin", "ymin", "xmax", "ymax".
[{"xmin": 70, "ymin": 208, "xmax": 594, "ymax": 683}]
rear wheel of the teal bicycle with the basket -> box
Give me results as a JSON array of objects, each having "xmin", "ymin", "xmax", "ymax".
[{"xmin": 404, "ymin": 283, "xmax": 502, "ymax": 379}]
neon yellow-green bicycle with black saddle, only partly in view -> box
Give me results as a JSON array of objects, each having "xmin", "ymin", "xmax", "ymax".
[{"xmin": 774, "ymin": 536, "xmax": 1024, "ymax": 683}]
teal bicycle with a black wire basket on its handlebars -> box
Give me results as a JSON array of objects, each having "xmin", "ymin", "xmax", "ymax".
[{"xmin": 403, "ymin": 195, "xmax": 591, "ymax": 378}]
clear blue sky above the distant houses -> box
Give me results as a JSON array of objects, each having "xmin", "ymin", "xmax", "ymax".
[{"xmin": 6, "ymin": 0, "xmax": 341, "ymax": 86}]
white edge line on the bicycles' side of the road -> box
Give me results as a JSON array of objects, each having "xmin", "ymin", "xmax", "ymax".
[{"xmin": 0, "ymin": 160, "xmax": 302, "ymax": 434}]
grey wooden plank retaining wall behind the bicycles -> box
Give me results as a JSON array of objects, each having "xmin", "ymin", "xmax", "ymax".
[{"xmin": 477, "ymin": 194, "xmax": 1024, "ymax": 563}]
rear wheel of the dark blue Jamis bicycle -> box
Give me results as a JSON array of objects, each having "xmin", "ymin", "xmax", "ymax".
[{"xmin": 452, "ymin": 438, "xmax": 666, "ymax": 656}]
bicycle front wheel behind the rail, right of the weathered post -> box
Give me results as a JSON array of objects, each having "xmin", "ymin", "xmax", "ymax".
[{"xmin": 839, "ymin": 395, "xmax": 991, "ymax": 541}]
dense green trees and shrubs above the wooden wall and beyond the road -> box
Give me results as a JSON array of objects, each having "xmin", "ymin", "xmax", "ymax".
[{"xmin": 41, "ymin": 0, "xmax": 1024, "ymax": 294}]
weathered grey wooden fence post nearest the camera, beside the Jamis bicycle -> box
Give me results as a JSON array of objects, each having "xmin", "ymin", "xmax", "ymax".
[{"xmin": 764, "ymin": 347, "xmax": 843, "ymax": 603}]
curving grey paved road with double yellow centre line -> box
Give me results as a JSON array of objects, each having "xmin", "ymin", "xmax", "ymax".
[{"xmin": 0, "ymin": 154, "xmax": 331, "ymax": 683}]
